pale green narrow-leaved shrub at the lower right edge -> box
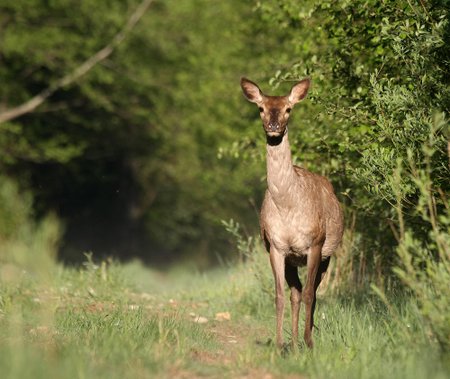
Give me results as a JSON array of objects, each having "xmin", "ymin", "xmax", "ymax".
[{"xmin": 390, "ymin": 124, "xmax": 450, "ymax": 352}]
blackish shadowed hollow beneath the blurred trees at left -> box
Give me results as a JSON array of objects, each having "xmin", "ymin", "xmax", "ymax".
[{"xmin": 32, "ymin": 159, "xmax": 150, "ymax": 262}]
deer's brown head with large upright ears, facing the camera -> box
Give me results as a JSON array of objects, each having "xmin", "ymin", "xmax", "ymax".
[{"xmin": 241, "ymin": 78, "xmax": 310, "ymax": 137}]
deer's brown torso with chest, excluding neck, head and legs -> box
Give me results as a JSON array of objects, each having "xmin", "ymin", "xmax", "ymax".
[{"xmin": 260, "ymin": 166, "xmax": 343, "ymax": 261}]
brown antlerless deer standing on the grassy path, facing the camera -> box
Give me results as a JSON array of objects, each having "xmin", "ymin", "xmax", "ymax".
[{"xmin": 241, "ymin": 77, "xmax": 344, "ymax": 350}]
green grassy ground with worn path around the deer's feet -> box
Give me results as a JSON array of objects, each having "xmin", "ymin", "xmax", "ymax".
[{"xmin": 0, "ymin": 254, "xmax": 450, "ymax": 379}]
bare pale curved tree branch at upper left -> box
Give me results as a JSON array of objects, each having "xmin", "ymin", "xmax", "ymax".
[{"xmin": 0, "ymin": 0, "xmax": 154, "ymax": 124}]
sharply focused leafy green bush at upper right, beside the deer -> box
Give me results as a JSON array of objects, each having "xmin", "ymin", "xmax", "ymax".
[{"xmin": 263, "ymin": 0, "xmax": 449, "ymax": 202}]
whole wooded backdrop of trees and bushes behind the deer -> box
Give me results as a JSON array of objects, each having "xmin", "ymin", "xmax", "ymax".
[{"xmin": 0, "ymin": 0, "xmax": 450, "ymax": 280}]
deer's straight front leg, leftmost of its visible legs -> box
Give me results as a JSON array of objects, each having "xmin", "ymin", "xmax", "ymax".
[{"xmin": 270, "ymin": 246, "xmax": 284, "ymax": 348}]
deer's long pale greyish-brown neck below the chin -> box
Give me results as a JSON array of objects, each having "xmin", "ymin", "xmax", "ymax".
[{"xmin": 266, "ymin": 132, "xmax": 296, "ymax": 199}]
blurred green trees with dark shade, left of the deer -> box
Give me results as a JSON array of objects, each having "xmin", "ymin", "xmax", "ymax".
[{"xmin": 0, "ymin": 0, "xmax": 284, "ymax": 264}]
